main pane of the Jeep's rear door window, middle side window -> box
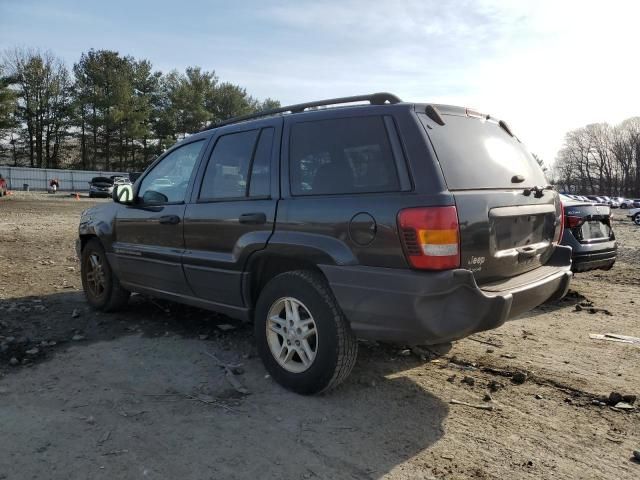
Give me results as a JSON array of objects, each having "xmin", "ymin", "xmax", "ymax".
[{"xmin": 200, "ymin": 130, "xmax": 258, "ymax": 199}]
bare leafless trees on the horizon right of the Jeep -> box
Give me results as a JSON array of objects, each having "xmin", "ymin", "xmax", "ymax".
[{"xmin": 553, "ymin": 117, "xmax": 640, "ymax": 198}]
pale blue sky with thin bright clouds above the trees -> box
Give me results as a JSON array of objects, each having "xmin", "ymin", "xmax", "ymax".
[{"xmin": 0, "ymin": 0, "xmax": 640, "ymax": 164}]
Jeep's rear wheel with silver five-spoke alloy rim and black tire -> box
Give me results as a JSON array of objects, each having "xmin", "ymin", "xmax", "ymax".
[{"xmin": 255, "ymin": 270, "xmax": 358, "ymax": 395}]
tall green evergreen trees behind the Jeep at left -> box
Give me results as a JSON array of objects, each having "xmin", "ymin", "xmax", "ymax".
[{"xmin": 0, "ymin": 48, "xmax": 280, "ymax": 171}]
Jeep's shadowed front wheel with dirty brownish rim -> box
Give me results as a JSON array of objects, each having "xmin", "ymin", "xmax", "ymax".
[{"xmin": 80, "ymin": 238, "xmax": 131, "ymax": 312}]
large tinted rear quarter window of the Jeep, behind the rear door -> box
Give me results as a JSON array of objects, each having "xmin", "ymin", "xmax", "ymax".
[{"xmin": 290, "ymin": 117, "xmax": 400, "ymax": 195}]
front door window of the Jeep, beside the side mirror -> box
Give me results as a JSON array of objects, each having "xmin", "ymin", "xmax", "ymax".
[{"xmin": 138, "ymin": 140, "xmax": 205, "ymax": 204}]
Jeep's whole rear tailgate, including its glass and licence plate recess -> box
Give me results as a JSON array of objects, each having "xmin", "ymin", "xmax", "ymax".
[{"xmin": 416, "ymin": 106, "xmax": 561, "ymax": 285}]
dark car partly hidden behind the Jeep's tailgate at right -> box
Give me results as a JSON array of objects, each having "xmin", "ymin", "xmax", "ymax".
[{"xmin": 561, "ymin": 195, "xmax": 618, "ymax": 272}]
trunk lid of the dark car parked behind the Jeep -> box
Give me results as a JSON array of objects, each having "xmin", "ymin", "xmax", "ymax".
[{"xmin": 564, "ymin": 203, "xmax": 615, "ymax": 244}]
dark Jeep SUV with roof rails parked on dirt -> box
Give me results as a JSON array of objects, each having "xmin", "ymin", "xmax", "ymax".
[{"xmin": 78, "ymin": 94, "xmax": 572, "ymax": 394}]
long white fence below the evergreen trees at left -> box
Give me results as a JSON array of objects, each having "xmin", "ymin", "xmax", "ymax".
[{"xmin": 0, "ymin": 167, "xmax": 129, "ymax": 192}]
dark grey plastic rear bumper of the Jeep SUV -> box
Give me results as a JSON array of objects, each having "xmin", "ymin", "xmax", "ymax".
[{"xmin": 321, "ymin": 247, "xmax": 572, "ymax": 344}]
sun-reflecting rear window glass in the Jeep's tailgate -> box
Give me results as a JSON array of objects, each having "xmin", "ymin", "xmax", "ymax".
[{"xmin": 418, "ymin": 114, "xmax": 548, "ymax": 190}]
